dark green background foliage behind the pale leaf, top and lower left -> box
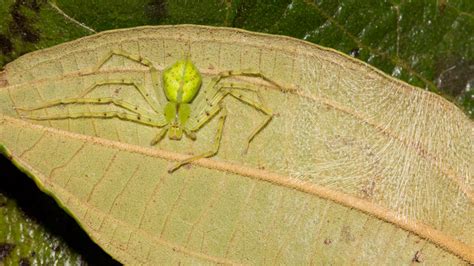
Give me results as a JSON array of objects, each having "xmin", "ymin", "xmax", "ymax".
[{"xmin": 0, "ymin": 0, "xmax": 474, "ymax": 264}]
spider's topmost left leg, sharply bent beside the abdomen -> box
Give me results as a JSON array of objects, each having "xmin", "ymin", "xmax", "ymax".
[{"xmin": 94, "ymin": 49, "xmax": 166, "ymax": 106}]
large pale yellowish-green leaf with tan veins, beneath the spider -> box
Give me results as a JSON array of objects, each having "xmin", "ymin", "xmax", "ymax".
[{"xmin": 0, "ymin": 26, "xmax": 474, "ymax": 264}]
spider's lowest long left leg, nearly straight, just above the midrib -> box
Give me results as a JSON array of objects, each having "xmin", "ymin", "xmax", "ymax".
[{"xmin": 21, "ymin": 111, "xmax": 168, "ymax": 128}]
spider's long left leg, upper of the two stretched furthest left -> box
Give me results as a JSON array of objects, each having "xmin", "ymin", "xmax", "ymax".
[{"xmin": 16, "ymin": 97, "xmax": 154, "ymax": 116}]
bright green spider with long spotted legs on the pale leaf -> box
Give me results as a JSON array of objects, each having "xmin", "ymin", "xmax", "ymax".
[{"xmin": 16, "ymin": 50, "xmax": 280, "ymax": 173}]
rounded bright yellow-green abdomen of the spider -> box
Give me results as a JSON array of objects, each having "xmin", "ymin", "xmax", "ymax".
[{"xmin": 163, "ymin": 59, "xmax": 202, "ymax": 103}]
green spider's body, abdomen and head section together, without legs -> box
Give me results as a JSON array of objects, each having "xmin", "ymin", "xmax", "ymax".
[{"xmin": 162, "ymin": 59, "xmax": 202, "ymax": 141}]
